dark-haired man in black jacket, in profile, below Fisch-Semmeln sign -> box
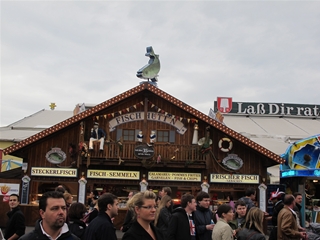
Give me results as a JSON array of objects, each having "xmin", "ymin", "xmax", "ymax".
[{"xmin": 84, "ymin": 193, "xmax": 119, "ymax": 240}]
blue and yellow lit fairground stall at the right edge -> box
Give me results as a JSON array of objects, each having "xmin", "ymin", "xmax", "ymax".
[{"xmin": 280, "ymin": 134, "xmax": 320, "ymax": 226}]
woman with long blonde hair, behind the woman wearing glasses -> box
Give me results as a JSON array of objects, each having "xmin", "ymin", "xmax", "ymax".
[{"xmin": 154, "ymin": 195, "xmax": 171, "ymax": 233}]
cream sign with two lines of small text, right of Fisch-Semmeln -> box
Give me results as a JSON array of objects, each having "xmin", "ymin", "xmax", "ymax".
[{"xmin": 148, "ymin": 172, "xmax": 201, "ymax": 182}]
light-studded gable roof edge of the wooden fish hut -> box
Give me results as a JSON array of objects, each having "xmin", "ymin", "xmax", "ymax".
[{"xmin": 3, "ymin": 82, "xmax": 284, "ymax": 163}]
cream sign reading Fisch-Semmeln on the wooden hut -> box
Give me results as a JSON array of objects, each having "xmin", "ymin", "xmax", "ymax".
[{"xmin": 87, "ymin": 169, "xmax": 140, "ymax": 180}]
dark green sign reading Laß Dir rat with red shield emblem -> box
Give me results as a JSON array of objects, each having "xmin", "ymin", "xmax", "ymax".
[{"xmin": 214, "ymin": 97, "xmax": 320, "ymax": 117}]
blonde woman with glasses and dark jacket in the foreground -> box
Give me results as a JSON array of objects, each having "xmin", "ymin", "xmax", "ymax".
[{"xmin": 122, "ymin": 191, "xmax": 164, "ymax": 240}]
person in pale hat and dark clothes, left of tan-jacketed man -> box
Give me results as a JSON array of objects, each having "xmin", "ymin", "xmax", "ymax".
[{"xmin": 269, "ymin": 188, "xmax": 285, "ymax": 240}]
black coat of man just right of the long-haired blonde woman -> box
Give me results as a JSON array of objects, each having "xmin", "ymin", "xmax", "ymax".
[{"xmin": 167, "ymin": 207, "xmax": 195, "ymax": 240}]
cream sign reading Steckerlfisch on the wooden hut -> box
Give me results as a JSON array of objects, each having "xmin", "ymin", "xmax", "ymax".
[{"xmin": 31, "ymin": 167, "xmax": 78, "ymax": 177}]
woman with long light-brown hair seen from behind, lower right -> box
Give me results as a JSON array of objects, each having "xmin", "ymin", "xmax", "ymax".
[{"xmin": 237, "ymin": 207, "xmax": 266, "ymax": 240}]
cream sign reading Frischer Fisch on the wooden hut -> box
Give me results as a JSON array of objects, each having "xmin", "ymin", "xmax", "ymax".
[{"xmin": 210, "ymin": 173, "xmax": 259, "ymax": 184}]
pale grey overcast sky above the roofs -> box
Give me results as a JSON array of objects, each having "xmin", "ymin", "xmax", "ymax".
[{"xmin": 0, "ymin": 1, "xmax": 320, "ymax": 126}]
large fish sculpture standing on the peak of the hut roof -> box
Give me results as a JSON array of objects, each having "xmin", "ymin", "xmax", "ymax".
[{"xmin": 137, "ymin": 46, "xmax": 160, "ymax": 83}]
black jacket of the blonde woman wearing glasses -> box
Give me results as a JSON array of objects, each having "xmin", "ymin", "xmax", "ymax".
[{"xmin": 122, "ymin": 221, "xmax": 165, "ymax": 240}]
